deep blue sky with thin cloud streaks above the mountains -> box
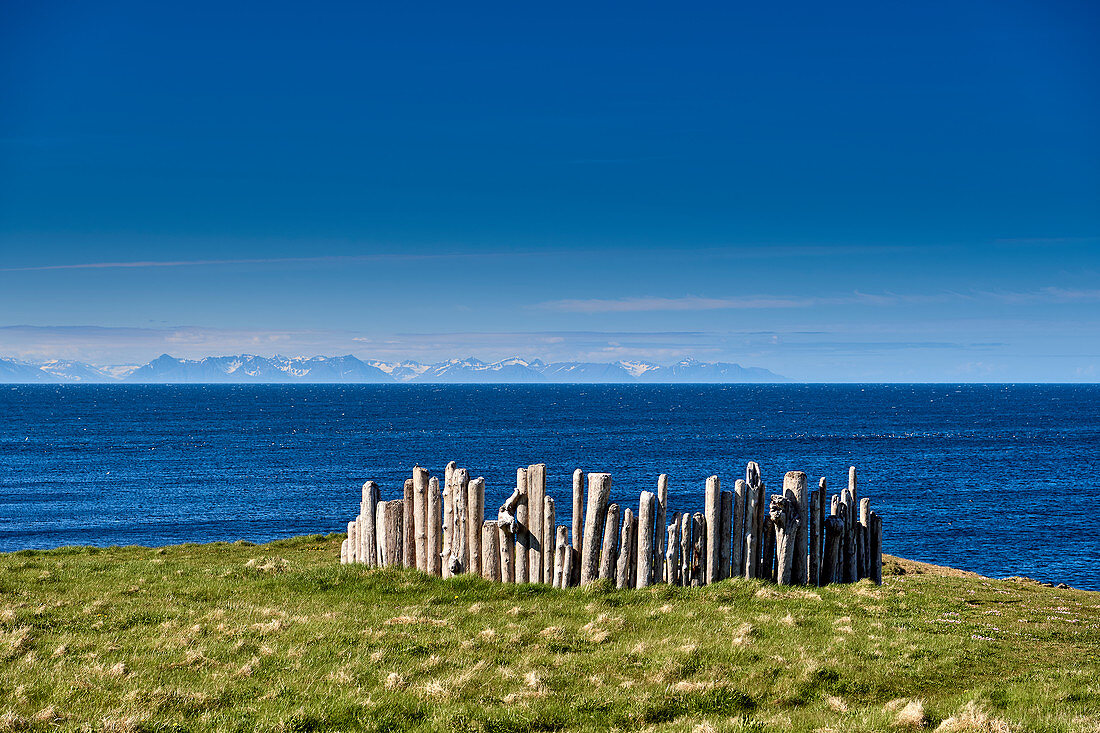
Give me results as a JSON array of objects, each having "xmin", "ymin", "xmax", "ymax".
[{"xmin": 0, "ymin": 0, "xmax": 1100, "ymax": 381}]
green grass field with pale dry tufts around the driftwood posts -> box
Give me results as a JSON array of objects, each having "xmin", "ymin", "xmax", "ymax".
[{"xmin": 0, "ymin": 535, "xmax": 1100, "ymax": 731}]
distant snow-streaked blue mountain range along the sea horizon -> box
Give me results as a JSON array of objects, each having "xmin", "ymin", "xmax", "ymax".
[{"xmin": 0, "ymin": 354, "xmax": 790, "ymax": 384}]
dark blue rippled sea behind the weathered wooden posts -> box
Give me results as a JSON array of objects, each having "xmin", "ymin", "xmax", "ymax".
[{"xmin": 0, "ymin": 384, "xmax": 1100, "ymax": 590}]
